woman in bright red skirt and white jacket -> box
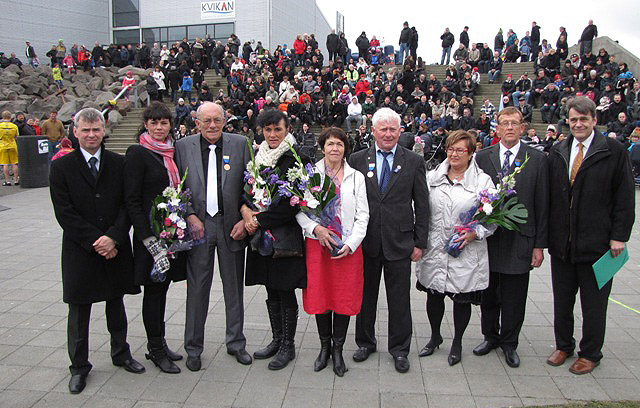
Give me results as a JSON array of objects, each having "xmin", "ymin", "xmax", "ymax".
[{"xmin": 296, "ymin": 127, "xmax": 369, "ymax": 377}]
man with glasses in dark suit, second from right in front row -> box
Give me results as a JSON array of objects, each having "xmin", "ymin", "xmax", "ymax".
[{"xmin": 473, "ymin": 107, "xmax": 549, "ymax": 367}]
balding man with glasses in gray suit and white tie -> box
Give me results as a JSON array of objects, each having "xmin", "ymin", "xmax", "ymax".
[{"xmin": 175, "ymin": 102, "xmax": 251, "ymax": 371}]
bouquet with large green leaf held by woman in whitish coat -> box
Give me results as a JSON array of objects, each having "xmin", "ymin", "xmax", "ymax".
[{"xmin": 444, "ymin": 155, "xmax": 529, "ymax": 258}]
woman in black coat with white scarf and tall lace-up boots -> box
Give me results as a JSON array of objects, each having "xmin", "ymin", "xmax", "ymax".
[{"xmin": 241, "ymin": 109, "xmax": 307, "ymax": 370}]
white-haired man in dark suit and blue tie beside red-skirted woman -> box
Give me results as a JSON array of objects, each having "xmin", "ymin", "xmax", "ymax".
[{"xmin": 349, "ymin": 108, "xmax": 429, "ymax": 373}]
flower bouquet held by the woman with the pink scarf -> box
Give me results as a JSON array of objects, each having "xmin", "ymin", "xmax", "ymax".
[{"xmin": 151, "ymin": 171, "xmax": 204, "ymax": 282}]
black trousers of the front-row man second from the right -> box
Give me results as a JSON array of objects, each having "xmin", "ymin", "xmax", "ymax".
[{"xmin": 480, "ymin": 272, "xmax": 530, "ymax": 350}]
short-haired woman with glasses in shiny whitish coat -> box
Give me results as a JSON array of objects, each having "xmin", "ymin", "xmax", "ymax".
[{"xmin": 416, "ymin": 130, "xmax": 495, "ymax": 365}]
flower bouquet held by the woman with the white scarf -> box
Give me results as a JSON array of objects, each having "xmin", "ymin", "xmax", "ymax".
[{"xmin": 244, "ymin": 139, "xmax": 280, "ymax": 212}]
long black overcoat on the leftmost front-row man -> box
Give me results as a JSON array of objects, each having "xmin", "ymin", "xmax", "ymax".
[{"xmin": 49, "ymin": 147, "xmax": 140, "ymax": 304}]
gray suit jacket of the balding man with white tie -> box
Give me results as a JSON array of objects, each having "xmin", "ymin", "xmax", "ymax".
[{"xmin": 175, "ymin": 133, "xmax": 250, "ymax": 251}]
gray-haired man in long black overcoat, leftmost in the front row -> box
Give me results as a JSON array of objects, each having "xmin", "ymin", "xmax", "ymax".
[{"xmin": 49, "ymin": 108, "xmax": 144, "ymax": 394}]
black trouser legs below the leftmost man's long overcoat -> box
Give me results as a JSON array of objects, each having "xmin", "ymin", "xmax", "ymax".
[{"xmin": 67, "ymin": 297, "xmax": 131, "ymax": 375}]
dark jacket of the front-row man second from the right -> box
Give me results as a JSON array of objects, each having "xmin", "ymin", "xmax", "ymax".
[{"xmin": 476, "ymin": 143, "xmax": 549, "ymax": 274}]
